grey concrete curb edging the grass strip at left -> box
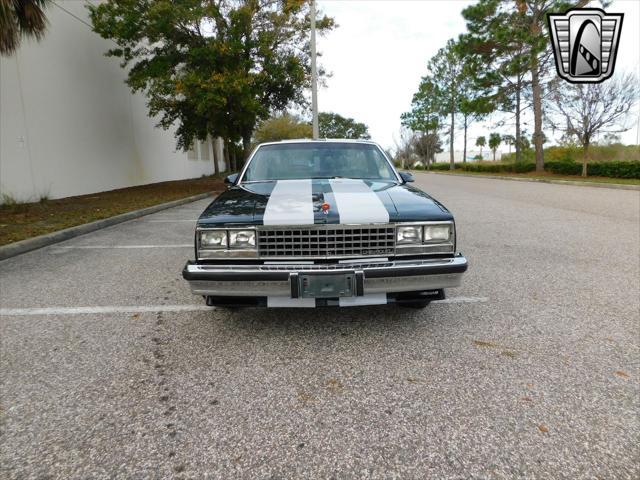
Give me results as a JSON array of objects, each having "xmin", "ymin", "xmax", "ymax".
[{"xmin": 0, "ymin": 192, "xmax": 212, "ymax": 260}]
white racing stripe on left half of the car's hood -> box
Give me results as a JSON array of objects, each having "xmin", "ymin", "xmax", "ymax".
[{"xmin": 262, "ymin": 180, "xmax": 314, "ymax": 225}]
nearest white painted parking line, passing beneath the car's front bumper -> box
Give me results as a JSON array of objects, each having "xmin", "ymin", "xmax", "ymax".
[{"xmin": 0, "ymin": 297, "xmax": 489, "ymax": 317}]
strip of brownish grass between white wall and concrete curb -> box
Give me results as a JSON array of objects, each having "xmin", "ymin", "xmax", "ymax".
[{"xmin": 0, "ymin": 176, "xmax": 225, "ymax": 245}]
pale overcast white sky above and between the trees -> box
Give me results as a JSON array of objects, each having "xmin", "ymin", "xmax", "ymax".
[{"xmin": 317, "ymin": 0, "xmax": 640, "ymax": 150}]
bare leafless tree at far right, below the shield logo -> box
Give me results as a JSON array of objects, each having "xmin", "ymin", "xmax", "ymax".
[{"xmin": 548, "ymin": 73, "xmax": 638, "ymax": 177}]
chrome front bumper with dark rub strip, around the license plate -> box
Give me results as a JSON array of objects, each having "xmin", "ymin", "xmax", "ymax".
[{"xmin": 182, "ymin": 255, "xmax": 467, "ymax": 298}]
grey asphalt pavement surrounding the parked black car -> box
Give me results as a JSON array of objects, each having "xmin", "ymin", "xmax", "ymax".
[{"xmin": 0, "ymin": 174, "xmax": 640, "ymax": 479}]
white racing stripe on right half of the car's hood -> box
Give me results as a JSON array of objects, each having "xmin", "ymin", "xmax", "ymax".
[{"xmin": 330, "ymin": 178, "xmax": 389, "ymax": 223}]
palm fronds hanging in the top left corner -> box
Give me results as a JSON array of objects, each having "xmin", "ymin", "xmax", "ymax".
[{"xmin": 0, "ymin": 0, "xmax": 51, "ymax": 56}]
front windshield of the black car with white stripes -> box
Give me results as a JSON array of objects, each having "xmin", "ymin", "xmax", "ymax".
[{"xmin": 242, "ymin": 143, "xmax": 398, "ymax": 182}]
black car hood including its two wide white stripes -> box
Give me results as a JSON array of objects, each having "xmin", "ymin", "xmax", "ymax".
[{"xmin": 198, "ymin": 179, "xmax": 453, "ymax": 226}]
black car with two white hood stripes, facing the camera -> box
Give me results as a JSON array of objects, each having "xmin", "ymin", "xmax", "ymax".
[{"xmin": 183, "ymin": 140, "xmax": 467, "ymax": 307}]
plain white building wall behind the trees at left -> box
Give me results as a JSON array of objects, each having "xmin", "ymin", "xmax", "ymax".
[{"xmin": 0, "ymin": 0, "xmax": 224, "ymax": 202}]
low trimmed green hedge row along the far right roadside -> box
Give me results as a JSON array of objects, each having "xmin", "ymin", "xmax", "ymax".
[{"xmin": 410, "ymin": 161, "xmax": 640, "ymax": 178}]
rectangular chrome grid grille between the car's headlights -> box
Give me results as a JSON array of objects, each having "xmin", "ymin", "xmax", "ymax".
[{"xmin": 257, "ymin": 225, "xmax": 395, "ymax": 258}]
